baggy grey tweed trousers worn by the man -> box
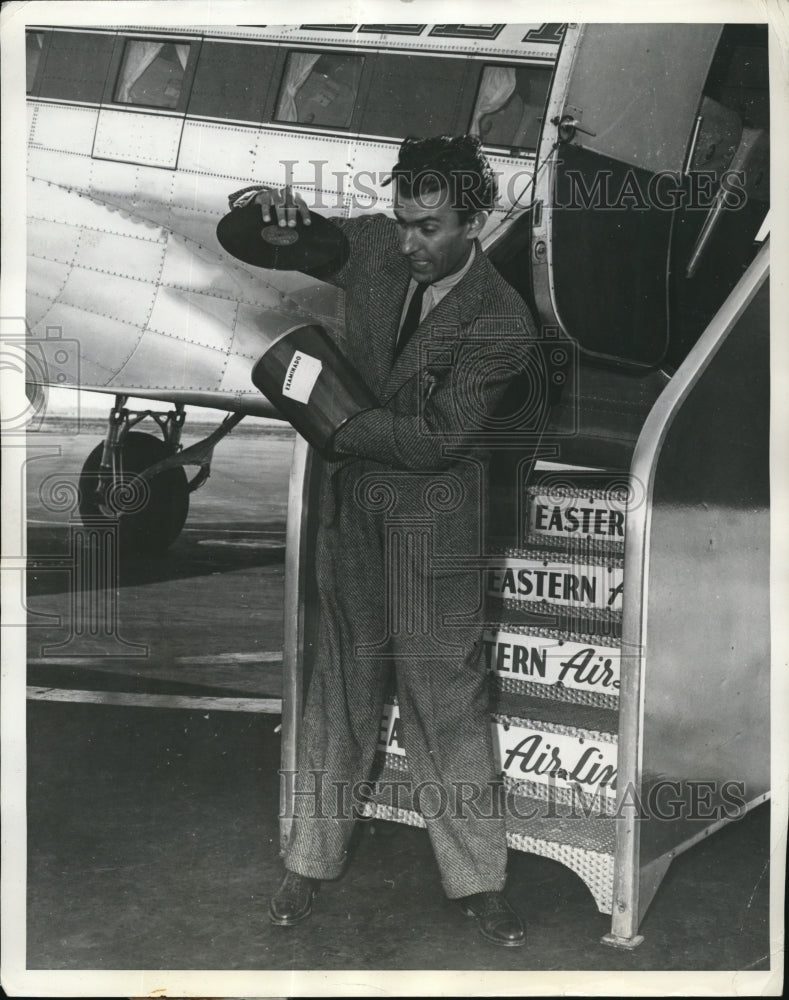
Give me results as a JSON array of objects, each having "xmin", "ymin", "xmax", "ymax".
[{"xmin": 285, "ymin": 468, "xmax": 507, "ymax": 898}]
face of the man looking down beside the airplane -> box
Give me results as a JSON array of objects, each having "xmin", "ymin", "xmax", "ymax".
[{"xmin": 394, "ymin": 190, "xmax": 486, "ymax": 284}]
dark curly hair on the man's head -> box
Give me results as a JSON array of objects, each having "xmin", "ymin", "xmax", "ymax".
[{"xmin": 384, "ymin": 135, "xmax": 496, "ymax": 221}]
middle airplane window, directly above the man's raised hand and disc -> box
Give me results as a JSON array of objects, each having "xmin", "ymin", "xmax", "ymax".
[{"xmin": 275, "ymin": 52, "xmax": 364, "ymax": 128}]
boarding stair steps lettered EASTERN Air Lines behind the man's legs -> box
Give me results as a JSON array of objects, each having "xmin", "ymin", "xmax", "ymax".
[{"xmin": 366, "ymin": 464, "xmax": 628, "ymax": 913}]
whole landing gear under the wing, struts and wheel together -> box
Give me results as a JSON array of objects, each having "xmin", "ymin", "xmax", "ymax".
[{"xmin": 79, "ymin": 395, "xmax": 244, "ymax": 554}]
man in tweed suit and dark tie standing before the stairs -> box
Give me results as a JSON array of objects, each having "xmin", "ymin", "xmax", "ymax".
[{"xmin": 232, "ymin": 136, "xmax": 534, "ymax": 947}]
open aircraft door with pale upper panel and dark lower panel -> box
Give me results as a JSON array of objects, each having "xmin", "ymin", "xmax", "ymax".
[{"xmin": 532, "ymin": 24, "xmax": 722, "ymax": 368}]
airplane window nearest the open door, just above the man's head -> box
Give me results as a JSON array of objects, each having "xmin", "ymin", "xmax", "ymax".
[{"xmin": 469, "ymin": 66, "xmax": 551, "ymax": 149}]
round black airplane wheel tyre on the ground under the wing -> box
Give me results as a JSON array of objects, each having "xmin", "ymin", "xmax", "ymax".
[{"xmin": 79, "ymin": 431, "xmax": 189, "ymax": 554}]
